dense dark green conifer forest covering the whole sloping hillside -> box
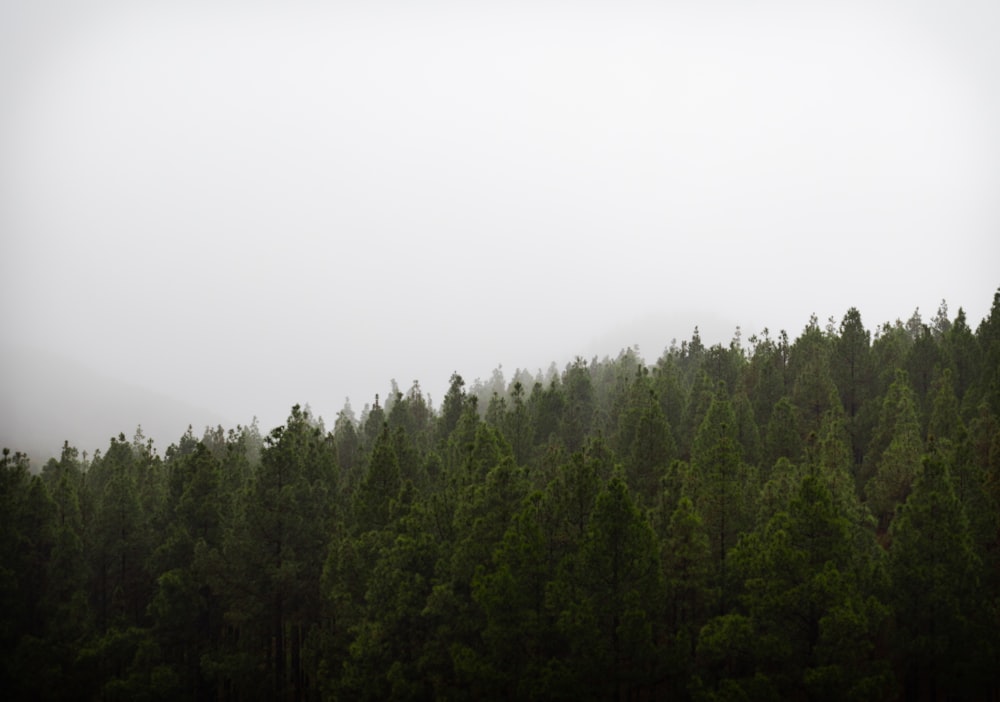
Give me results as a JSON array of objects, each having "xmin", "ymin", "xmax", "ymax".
[{"xmin": 0, "ymin": 292, "xmax": 1000, "ymax": 700}]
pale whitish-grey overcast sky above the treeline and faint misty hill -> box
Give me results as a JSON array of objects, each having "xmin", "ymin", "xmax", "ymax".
[{"xmin": 0, "ymin": 0, "xmax": 1000, "ymax": 452}]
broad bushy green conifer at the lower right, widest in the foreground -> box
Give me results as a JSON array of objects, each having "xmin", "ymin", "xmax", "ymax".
[{"xmin": 705, "ymin": 475, "xmax": 891, "ymax": 700}]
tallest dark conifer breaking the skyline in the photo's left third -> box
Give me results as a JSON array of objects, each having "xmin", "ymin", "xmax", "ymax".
[{"xmin": 219, "ymin": 405, "xmax": 337, "ymax": 699}]
